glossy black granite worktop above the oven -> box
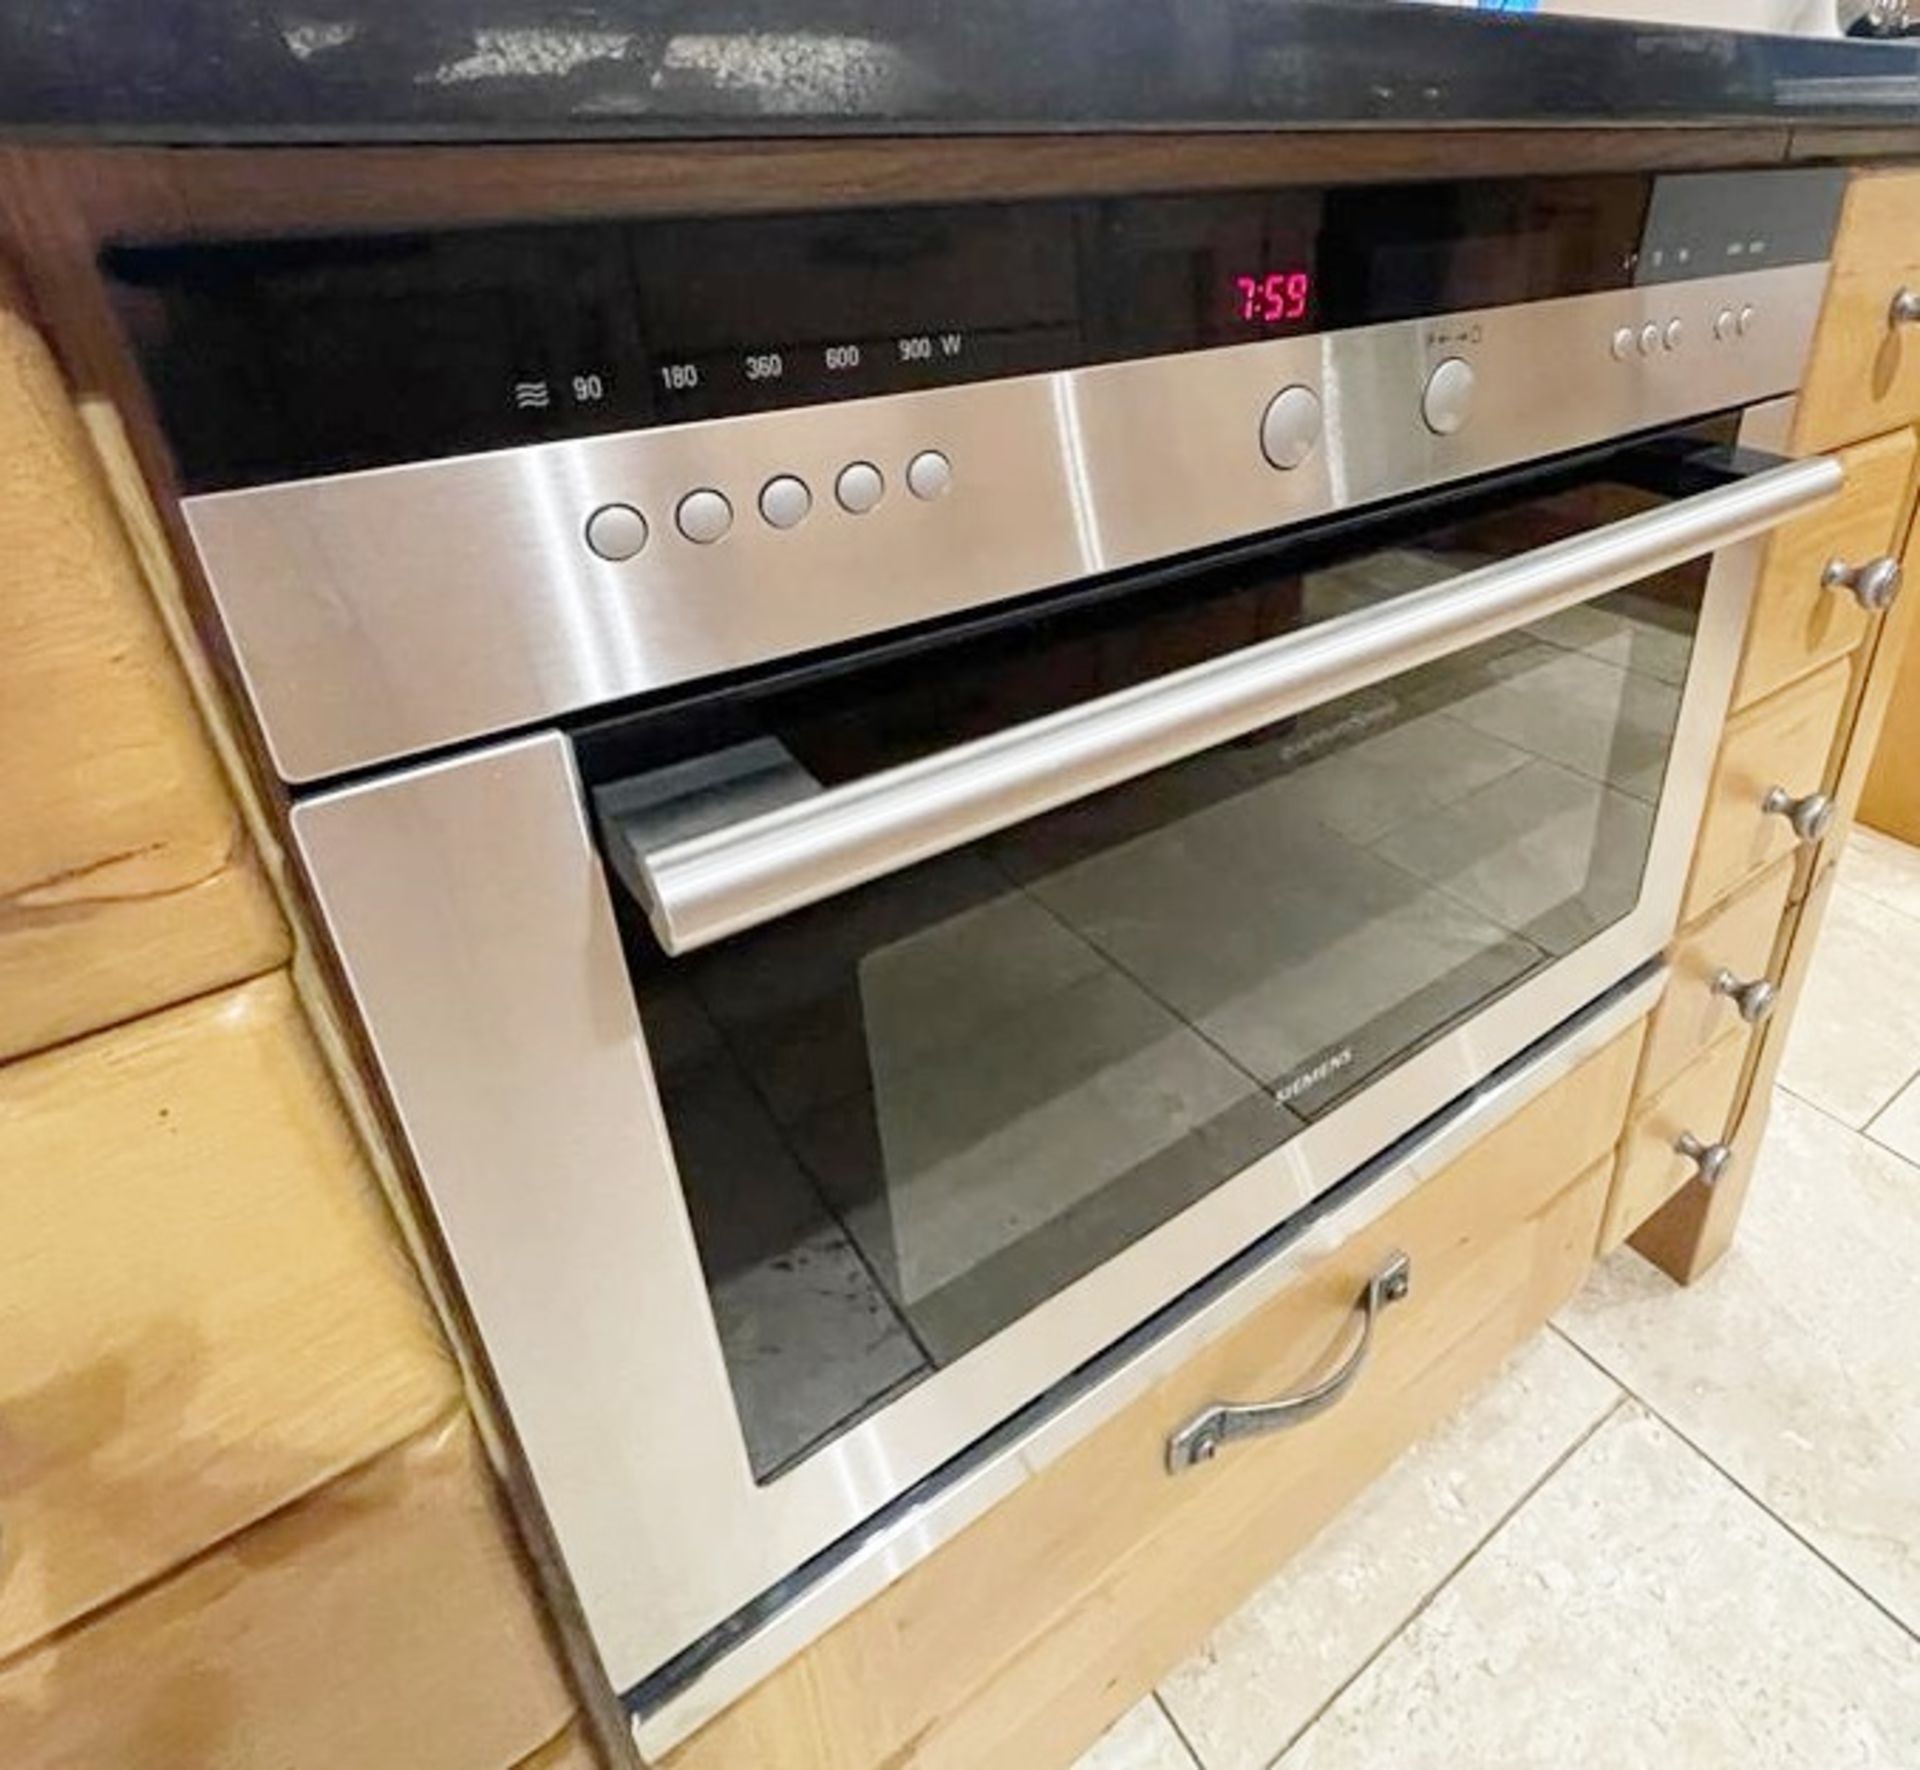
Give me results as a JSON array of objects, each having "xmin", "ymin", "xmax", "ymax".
[{"xmin": 11, "ymin": 0, "xmax": 1920, "ymax": 142}]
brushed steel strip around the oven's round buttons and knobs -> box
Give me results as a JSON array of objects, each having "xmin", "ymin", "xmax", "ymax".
[{"xmin": 184, "ymin": 265, "xmax": 1826, "ymax": 781}]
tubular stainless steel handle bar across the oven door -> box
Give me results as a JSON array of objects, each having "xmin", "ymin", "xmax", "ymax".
[{"xmin": 634, "ymin": 455, "xmax": 1845, "ymax": 954}]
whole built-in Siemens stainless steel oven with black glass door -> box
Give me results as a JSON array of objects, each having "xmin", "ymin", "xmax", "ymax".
[{"xmin": 109, "ymin": 158, "xmax": 1841, "ymax": 1743}]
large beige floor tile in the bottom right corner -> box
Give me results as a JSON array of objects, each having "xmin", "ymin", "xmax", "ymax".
[{"xmin": 1281, "ymin": 1405, "xmax": 1920, "ymax": 1770}]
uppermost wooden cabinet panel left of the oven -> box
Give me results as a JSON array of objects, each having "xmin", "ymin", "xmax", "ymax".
[{"xmin": 0, "ymin": 268, "xmax": 286, "ymax": 1058}]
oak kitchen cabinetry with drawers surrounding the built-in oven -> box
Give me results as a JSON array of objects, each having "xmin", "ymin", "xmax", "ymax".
[{"xmin": 0, "ymin": 134, "xmax": 1920, "ymax": 1770}]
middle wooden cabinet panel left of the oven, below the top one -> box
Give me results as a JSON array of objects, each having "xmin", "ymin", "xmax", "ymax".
[{"xmin": 0, "ymin": 975, "xmax": 459, "ymax": 1658}]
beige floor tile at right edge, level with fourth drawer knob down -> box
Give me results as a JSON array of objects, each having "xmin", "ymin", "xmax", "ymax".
[{"xmin": 1780, "ymin": 885, "xmax": 1920, "ymax": 1129}]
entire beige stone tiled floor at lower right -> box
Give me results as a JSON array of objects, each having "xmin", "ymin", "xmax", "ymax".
[{"xmin": 1081, "ymin": 831, "xmax": 1920, "ymax": 1770}]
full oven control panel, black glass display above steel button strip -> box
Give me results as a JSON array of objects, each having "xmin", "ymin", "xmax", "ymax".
[{"xmin": 115, "ymin": 171, "xmax": 1839, "ymax": 783}]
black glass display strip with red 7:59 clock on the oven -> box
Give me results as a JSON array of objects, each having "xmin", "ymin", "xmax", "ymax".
[{"xmin": 106, "ymin": 169, "xmax": 1843, "ymax": 495}]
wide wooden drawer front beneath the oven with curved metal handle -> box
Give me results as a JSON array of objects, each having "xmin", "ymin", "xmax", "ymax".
[{"xmin": 668, "ymin": 1027, "xmax": 1642, "ymax": 1770}]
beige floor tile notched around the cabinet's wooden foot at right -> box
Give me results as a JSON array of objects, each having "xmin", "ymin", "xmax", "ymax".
[{"xmin": 1559, "ymin": 1094, "xmax": 1920, "ymax": 1627}]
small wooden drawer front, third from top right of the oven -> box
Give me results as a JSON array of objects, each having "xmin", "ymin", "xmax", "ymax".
[{"xmin": 1680, "ymin": 658, "xmax": 1851, "ymax": 921}]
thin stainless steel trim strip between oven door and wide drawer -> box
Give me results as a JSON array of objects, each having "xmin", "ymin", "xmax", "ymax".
[{"xmin": 634, "ymin": 968, "xmax": 1668, "ymax": 1762}]
